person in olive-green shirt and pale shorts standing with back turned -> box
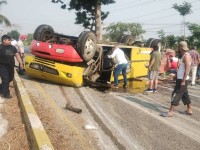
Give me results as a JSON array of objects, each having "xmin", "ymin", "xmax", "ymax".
[{"xmin": 146, "ymin": 46, "xmax": 161, "ymax": 92}]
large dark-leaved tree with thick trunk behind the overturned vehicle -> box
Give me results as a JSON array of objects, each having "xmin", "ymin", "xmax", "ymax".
[{"xmin": 52, "ymin": 0, "xmax": 115, "ymax": 40}]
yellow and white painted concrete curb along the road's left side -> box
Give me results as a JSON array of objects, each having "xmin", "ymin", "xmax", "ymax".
[{"xmin": 13, "ymin": 70, "xmax": 54, "ymax": 150}]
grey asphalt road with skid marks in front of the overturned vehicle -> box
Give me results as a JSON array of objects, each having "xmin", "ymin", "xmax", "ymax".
[{"xmin": 18, "ymin": 72, "xmax": 200, "ymax": 150}]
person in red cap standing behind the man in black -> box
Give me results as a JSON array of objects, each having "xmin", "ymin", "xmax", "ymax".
[{"xmin": 17, "ymin": 35, "xmax": 26, "ymax": 75}]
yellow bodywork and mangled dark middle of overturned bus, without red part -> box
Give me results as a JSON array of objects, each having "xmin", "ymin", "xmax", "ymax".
[{"xmin": 25, "ymin": 44, "xmax": 151, "ymax": 87}]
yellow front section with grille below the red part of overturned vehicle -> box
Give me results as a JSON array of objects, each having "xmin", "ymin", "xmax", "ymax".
[{"xmin": 24, "ymin": 56, "xmax": 84, "ymax": 87}]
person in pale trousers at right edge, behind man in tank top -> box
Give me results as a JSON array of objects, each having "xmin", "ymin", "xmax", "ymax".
[{"xmin": 190, "ymin": 47, "xmax": 200, "ymax": 86}]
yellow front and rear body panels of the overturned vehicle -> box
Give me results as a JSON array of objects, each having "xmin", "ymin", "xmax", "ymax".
[{"xmin": 25, "ymin": 44, "xmax": 151, "ymax": 87}]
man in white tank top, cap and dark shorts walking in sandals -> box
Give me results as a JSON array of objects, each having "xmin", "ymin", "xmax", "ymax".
[{"xmin": 161, "ymin": 41, "xmax": 192, "ymax": 117}]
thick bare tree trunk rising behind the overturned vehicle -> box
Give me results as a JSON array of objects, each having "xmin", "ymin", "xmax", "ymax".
[{"xmin": 95, "ymin": 3, "xmax": 102, "ymax": 40}]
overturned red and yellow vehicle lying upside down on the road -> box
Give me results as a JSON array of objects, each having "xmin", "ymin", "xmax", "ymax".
[{"xmin": 25, "ymin": 25, "xmax": 161, "ymax": 87}]
